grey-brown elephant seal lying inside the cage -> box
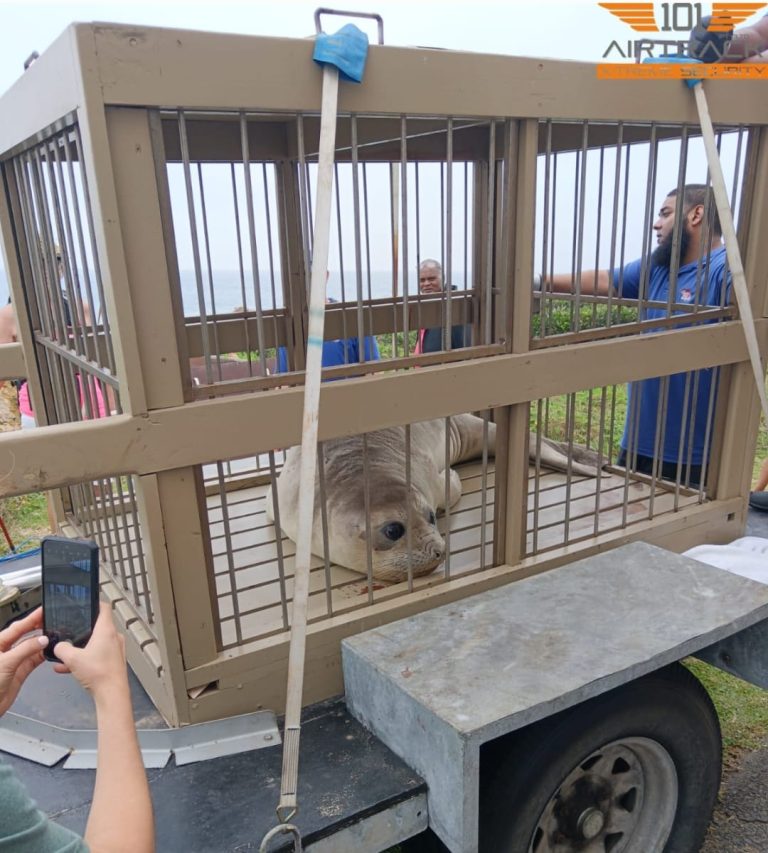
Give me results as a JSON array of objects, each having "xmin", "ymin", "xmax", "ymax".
[{"xmin": 266, "ymin": 415, "xmax": 598, "ymax": 582}]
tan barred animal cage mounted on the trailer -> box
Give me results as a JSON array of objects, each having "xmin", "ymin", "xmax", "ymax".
[{"xmin": 0, "ymin": 24, "xmax": 768, "ymax": 725}]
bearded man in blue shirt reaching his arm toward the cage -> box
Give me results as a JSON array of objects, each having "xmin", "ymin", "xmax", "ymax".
[{"xmin": 534, "ymin": 184, "xmax": 731, "ymax": 487}]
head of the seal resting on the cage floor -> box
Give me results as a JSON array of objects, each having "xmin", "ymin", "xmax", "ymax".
[{"xmin": 328, "ymin": 481, "xmax": 445, "ymax": 583}]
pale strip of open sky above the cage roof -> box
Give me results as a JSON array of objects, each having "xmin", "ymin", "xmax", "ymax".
[{"xmin": 0, "ymin": 0, "xmax": 760, "ymax": 301}]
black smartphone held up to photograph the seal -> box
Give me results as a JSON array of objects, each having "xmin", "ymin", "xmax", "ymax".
[{"xmin": 42, "ymin": 536, "xmax": 99, "ymax": 661}]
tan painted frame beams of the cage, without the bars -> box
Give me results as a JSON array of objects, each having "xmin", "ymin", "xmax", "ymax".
[{"xmin": 0, "ymin": 24, "xmax": 768, "ymax": 725}]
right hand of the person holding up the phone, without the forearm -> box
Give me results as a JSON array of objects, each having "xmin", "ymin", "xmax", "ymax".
[{"xmin": 53, "ymin": 601, "xmax": 128, "ymax": 701}]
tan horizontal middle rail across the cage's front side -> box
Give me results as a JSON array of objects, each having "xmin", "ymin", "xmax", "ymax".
[{"xmin": 0, "ymin": 320, "xmax": 756, "ymax": 495}]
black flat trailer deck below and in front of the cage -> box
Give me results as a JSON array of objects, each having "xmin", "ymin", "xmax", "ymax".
[{"xmin": 0, "ymin": 667, "xmax": 427, "ymax": 853}]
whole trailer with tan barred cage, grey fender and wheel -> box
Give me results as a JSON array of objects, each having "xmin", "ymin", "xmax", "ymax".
[{"xmin": 0, "ymin": 24, "xmax": 768, "ymax": 853}]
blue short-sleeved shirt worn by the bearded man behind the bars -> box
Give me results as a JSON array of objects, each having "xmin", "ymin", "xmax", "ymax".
[{"xmin": 613, "ymin": 248, "xmax": 731, "ymax": 465}]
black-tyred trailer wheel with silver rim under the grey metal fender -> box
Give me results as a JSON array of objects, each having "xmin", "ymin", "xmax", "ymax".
[{"xmin": 480, "ymin": 664, "xmax": 722, "ymax": 853}]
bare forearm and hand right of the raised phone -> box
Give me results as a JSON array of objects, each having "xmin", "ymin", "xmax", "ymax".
[{"xmin": 54, "ymin": 603, "xmax": 155, "ymax": 853}]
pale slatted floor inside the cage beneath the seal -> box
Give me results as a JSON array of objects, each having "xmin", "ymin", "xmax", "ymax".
[{"xmin": 207, "ymin": 461, "xmax": 699, "ymax": 648}]
